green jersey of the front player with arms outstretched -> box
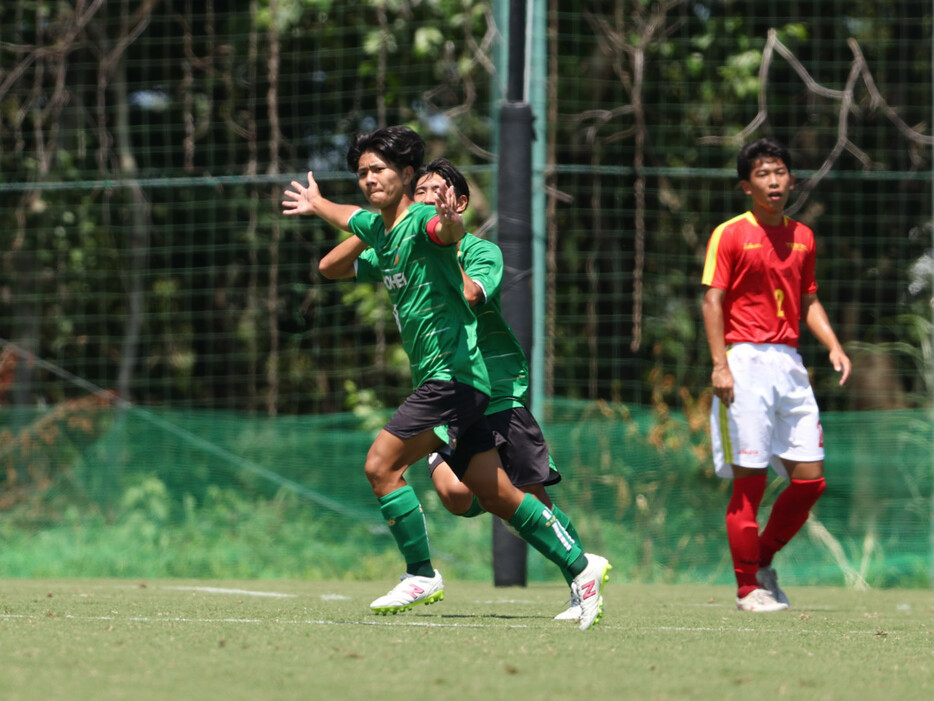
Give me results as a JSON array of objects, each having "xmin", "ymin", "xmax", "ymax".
[{"xmin": 349, "ymin": 203, "xmax": 490, "ymax": 394}]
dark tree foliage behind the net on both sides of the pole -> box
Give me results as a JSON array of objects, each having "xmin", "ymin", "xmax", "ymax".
[{"xmin": 0, "ymin": 0, "xmax": 931, "ymax": 414}]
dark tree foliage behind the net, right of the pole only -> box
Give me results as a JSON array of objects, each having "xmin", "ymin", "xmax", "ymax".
[{"xmin": 548, "ymin": 1, "xmax": 932, "ymax": 408}]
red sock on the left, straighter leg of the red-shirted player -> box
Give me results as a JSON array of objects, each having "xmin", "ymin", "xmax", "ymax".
[{"xmin": 726, "ymin": 470, "xmax": 767, "ymax": 598}]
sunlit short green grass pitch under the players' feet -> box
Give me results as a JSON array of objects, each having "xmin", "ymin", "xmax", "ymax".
[{"xmin": 0, "ymin": 579, "xmax": 934, "ymax": 701}]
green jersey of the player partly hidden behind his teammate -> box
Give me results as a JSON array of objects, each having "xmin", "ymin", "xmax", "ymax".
[{"xmin": 357, "ymin": 227, "xmax": 529, "ymax": 414}]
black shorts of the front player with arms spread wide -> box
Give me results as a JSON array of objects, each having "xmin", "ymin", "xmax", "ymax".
[{"xmin": 383, "ymin": 380, "xmax": 496, "ymax": 478}]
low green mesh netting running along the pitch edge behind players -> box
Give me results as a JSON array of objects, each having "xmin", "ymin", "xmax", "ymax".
[{"xmin": 0, "ymin": 400, "xmax": 934, "ymax": 586}]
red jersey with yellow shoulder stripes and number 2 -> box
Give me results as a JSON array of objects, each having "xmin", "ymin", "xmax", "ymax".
[{"xmin": 702, "ymin": 212, "xmax": 817, "ymax": 347}]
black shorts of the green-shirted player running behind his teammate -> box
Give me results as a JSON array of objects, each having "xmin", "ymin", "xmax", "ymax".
[{"xmin": 428, "ymin": 407, "xmax": 561, "ymax": 487}]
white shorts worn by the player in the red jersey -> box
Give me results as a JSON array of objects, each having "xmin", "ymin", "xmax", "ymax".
[{"xmin": 710, "ymin": 343, "xmax": 824, "ymax": 479}]
